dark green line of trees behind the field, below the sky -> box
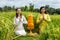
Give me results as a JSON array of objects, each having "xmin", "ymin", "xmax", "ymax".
[{"xmin": 0, "ymin": 3, "xmax": 60, "ymax": 15}]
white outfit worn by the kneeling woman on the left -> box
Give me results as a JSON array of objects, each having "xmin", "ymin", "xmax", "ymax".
[{"xmin": 14, "ymin": 16, "xmax": 27, "ymax": 35}]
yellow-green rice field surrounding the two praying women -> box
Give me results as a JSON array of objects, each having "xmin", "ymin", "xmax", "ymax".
[{"xmin": 0, "ymin": 11, "xmax": 60, "ymax": 40}]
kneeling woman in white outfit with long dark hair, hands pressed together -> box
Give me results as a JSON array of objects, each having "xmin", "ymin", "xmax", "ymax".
[{"xmin": 14, "ymin": 8, "xmax": 27, "ymax": 36}]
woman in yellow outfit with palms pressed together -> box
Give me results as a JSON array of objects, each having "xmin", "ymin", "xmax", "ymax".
[{"xmin": 37, "ymin": 7, "xmax": 51, "ymax": 33}]
